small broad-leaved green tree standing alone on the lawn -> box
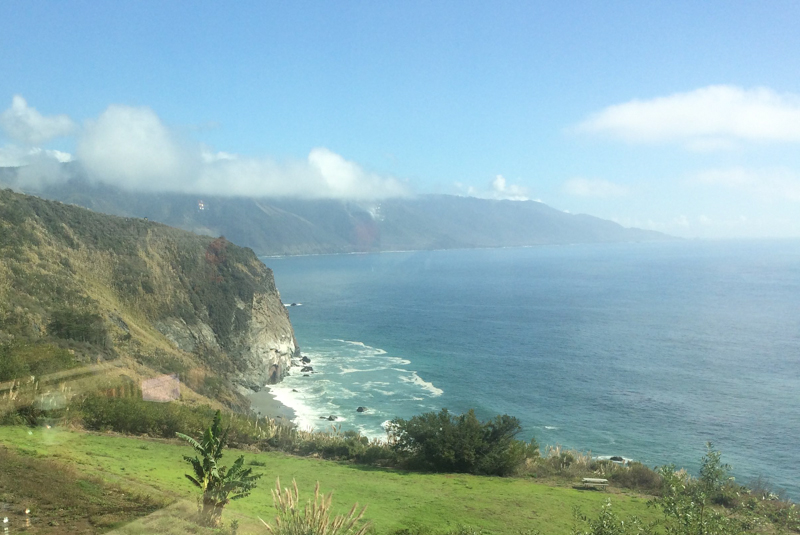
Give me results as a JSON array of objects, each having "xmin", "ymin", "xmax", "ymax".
[{"xmin": 175, "ymin": 411, "xmax": 261, "ymax": 527}]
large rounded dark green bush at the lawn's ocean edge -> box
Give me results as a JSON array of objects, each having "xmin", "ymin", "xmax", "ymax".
[{"xmin": 390, "ymin": 409, "xmax": 538, "ymax": 476}]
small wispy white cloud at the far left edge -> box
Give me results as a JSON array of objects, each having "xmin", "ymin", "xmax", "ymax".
[{"xmin": 0, "ymin": 95, "xmax": 75, "ymax": 145}]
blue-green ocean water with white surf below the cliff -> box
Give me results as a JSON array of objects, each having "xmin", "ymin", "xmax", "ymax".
[{"xmin": 263, "ymin": 241, "xmax": 800, "ymax": 499}]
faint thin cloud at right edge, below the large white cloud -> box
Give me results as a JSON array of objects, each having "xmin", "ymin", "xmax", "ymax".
[{"xmin": 695, "ymin": 167, "xmax": 800, "ymax": 202}]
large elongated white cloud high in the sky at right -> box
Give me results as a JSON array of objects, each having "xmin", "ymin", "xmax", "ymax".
[{"xmin": 575, "ymin": 85, "xmax": 800, "ymax": 151}]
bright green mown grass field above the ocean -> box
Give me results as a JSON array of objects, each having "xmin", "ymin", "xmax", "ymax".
[{"xmin": 0, "ymin": 427, "xmax": 656, "ymax": 535}]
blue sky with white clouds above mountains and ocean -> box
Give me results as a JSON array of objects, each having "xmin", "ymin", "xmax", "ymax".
[{"xmin": 0, "ymin": 0, "xmax": 800, "ymax": 238}]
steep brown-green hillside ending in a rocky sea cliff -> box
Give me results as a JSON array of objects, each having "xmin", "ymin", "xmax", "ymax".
[{"xmin": 0, "ymin": 190, "xmax": 297, "ymax": 407}]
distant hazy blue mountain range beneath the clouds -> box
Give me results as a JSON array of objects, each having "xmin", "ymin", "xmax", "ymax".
[{"xmin": 0, "ymin": 164, "xmax": 672, "ymax": 256}]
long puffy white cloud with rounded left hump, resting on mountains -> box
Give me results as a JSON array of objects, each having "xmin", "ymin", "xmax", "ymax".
[{"xmin": 77, "ymin": 105, "xmax": 407, "ymax": 200}]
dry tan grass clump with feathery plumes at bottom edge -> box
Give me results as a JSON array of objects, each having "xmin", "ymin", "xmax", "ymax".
[{"xmin": 259, "ymin": 478, "xmax": 370, "ymax": 535}]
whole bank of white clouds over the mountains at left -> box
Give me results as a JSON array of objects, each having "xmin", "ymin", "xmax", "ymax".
[{"xmin": 0, "ymin": 97, "xmax": 409, "ymax": 200}]
